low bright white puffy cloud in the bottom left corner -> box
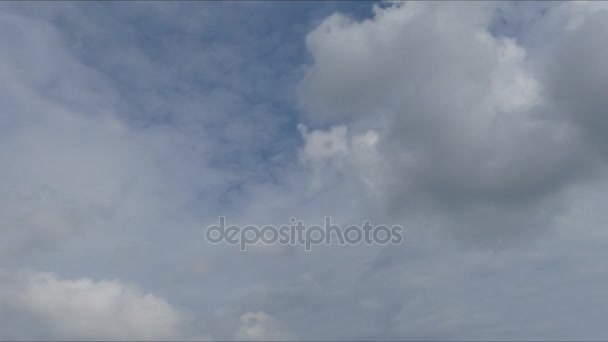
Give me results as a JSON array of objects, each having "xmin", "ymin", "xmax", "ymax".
[{"xmin": 0, "ymin": 273, "xmax": 182, "ymax": 340}]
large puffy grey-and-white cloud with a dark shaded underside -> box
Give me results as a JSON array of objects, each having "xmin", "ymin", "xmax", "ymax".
[{"xmin": 300, "ymin": 2, "xmax": 603, "ymax": 243}]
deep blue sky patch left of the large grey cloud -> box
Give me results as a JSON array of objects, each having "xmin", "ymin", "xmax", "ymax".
[{"xmin": 41, "ymin": 1, "xmax": 380, "ymax": 182}]
